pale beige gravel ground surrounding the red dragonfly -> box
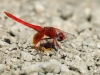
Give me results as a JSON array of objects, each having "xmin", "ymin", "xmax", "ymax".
[{"xmin": 0, "ymin": 0, "xmax": 100, "ymax": 75}]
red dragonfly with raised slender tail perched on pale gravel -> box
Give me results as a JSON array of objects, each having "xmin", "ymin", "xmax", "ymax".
[{"xmin": 4, "ymin": 12, "xmax": 75, "ymax": 51}]
